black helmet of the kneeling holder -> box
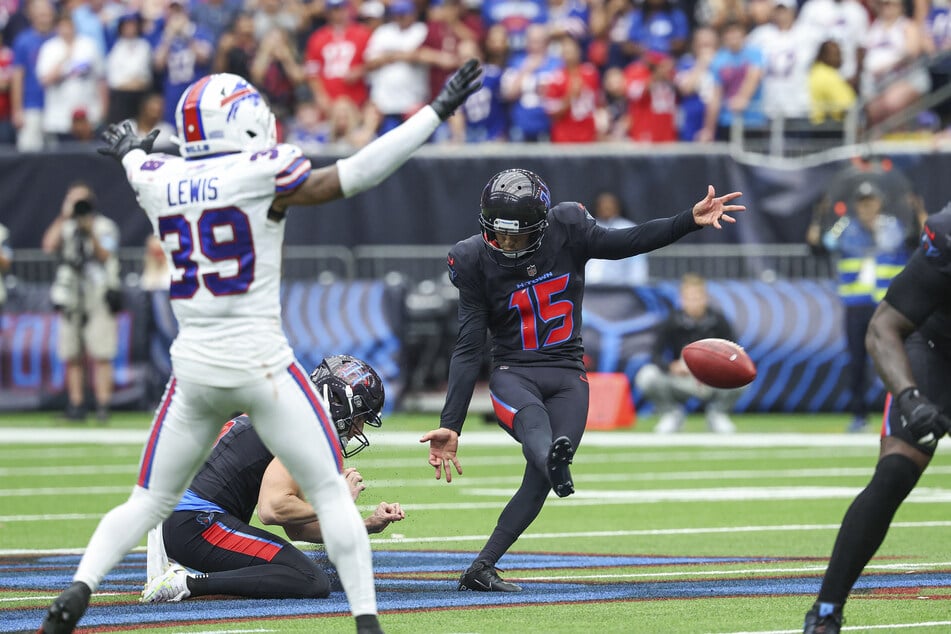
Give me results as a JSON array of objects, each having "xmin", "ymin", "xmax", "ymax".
[{"xmin": 310, "ymin": 354, "xmax": 386, "ymax": 458}]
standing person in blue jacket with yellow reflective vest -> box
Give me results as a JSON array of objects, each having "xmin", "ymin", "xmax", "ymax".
[{"xmin": 807, "ymin": 174, "xmax": 909, "ymax": 432}]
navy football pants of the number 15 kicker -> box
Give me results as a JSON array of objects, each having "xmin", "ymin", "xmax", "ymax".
[{"xmin": 477, "ymin": 366, "xmax": 588, "ymax": 565}]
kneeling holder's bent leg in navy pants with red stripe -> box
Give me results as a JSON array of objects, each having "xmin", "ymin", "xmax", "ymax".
[{"xmin": 156, "ymin": 511, "xmax": 330, "ymax": 599}]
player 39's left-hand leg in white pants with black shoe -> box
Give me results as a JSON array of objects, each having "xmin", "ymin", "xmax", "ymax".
[{"xmin": 41, "ymin": 377, "xmax": 219, "ymax": 633}]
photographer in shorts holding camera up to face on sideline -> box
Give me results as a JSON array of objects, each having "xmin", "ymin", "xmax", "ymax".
[{"xmin": 43, "ymin": 181, "xmax": 122, "ymax": 422}]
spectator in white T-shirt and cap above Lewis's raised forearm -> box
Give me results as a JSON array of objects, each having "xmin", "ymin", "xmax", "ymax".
[{"xmin": 365, "ymin": 0, "xmax": 429, "ymax": 135}]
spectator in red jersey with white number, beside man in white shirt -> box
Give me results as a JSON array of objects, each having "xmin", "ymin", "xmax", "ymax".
[{"xmin": 304, "ymin": 0, "xmax": 371, "ymax": 116}]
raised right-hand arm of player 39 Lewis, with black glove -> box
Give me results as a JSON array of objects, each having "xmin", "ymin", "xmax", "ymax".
[{"xmin": 273, "ymin": 59, "xmax": 482, "ymax": 212}]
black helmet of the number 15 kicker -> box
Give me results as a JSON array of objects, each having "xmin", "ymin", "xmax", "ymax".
[{"xmin": 479, "ymin": 169, "xmax": 551, "ymax": 266}]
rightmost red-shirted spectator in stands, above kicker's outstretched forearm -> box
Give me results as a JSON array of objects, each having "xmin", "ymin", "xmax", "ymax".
[{"xmin": 624, "ymin": 51, "xmax": 677, "ymax": 143}]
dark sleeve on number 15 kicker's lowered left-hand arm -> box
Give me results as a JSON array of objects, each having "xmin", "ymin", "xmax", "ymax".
[{"xmin": 439, "ymin": 253, "xmax": 489, "ymax": 433}]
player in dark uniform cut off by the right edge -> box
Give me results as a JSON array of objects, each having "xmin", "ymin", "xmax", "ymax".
[{"xmin": 803, "ymin": 207, "xmax": 951, "ymax": 634}]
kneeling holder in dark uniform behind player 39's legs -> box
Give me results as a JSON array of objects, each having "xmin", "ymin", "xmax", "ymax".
[{"xmin": 141, "ymin": 355, "xmax": 406, "ymax": 603}]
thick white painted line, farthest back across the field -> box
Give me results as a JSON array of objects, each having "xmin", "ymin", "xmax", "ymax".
[{"xmin": 0, "ymin": 427, "xmax": 879, "ymax": 449}]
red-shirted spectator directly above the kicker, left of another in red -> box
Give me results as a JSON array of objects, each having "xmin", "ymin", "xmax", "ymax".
[{"xmin": 545, "ymin": 36, "xmax": 603, "ymax": 143}]
